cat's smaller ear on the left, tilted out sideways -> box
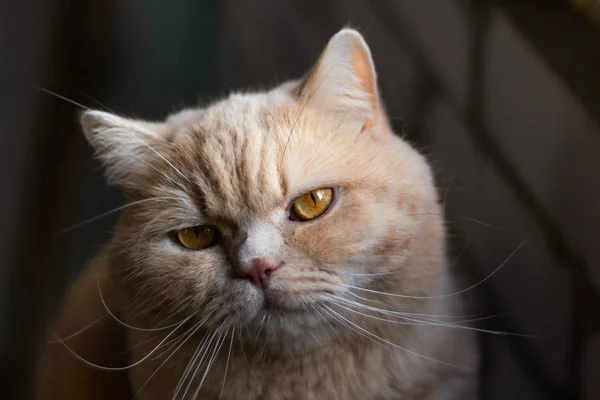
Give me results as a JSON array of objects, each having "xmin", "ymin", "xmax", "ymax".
[{"xmin": 80, "ymin": 111, "xmax": 168, "ymax": 187}]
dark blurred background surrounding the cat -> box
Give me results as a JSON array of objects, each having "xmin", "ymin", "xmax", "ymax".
[{"xmin": 0, "ymin": 0, "xmax": 600, "ymax": 399}]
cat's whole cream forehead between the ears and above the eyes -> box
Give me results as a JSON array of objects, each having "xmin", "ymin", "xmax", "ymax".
[{"xmin": 159, "ymin": 94, "xmax": 389, "ymax": 220}]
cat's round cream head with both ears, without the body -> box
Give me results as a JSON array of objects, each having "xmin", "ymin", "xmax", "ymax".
[{"xmin": 82, "ymin": 29, "xmax": 443, "ymax": 346}]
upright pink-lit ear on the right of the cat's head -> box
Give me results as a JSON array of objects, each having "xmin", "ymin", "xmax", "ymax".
[{"xmin": 296, "ymin": 29, "xmax": 387, "ymax": 131}]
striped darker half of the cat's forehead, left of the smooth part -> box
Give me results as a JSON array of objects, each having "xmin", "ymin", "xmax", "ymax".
[{"xmin": 170, "ymin": 95, "xmax": 294, "ymax": 220}]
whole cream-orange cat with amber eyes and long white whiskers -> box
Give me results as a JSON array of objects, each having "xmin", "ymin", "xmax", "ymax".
[{"xmin": 37, "ymin": 28, "xmax": 478, "ymax": 400}]
